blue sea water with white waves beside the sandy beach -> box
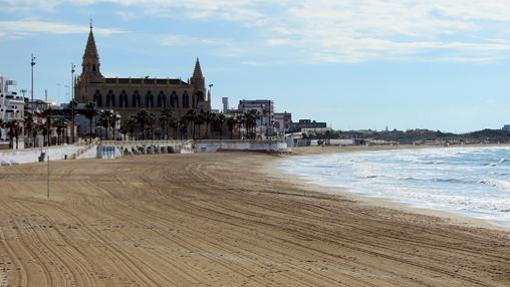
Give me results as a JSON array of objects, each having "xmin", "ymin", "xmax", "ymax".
[{"xmin": 281, "ymin": 147, "xmax": 510, "ymax": 227}]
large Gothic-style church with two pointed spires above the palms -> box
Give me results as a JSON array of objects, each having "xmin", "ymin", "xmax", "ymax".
[{"xmin": 75, "ymin": 23, "xmax": 211, "ymax": 128}]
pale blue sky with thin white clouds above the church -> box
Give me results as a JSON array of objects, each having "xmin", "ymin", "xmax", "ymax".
[{"xmin": 0, "ymin": 0, "xmax": 510, "ymax": 132}]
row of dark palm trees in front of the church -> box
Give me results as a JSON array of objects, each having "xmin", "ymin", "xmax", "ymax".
[{"xmin": 0, "ymin": 101, "xmax": 261, "ymax": 148}]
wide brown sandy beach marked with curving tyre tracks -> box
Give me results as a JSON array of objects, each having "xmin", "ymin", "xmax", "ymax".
[{"xmin": 0, "ymin": 153, "xmax": 510, "ymax": 287}]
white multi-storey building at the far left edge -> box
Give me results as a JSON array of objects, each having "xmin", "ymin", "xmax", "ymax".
[{"xmin": 0, "ymin": 76, "xmax": 25, "ymax": 149}]
